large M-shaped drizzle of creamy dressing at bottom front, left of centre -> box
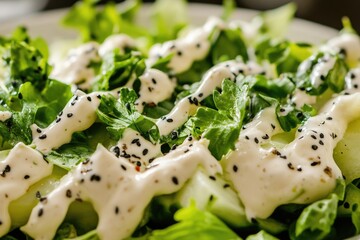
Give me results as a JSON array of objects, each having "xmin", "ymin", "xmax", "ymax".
[{"xmin": 21, "ymin": 140, "xmax": 221, "ymax": 240}]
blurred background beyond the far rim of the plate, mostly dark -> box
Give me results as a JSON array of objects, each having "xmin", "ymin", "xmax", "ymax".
[{"xmin": 0, "ymin": 0, "xmax": 360, "ymax": 32}]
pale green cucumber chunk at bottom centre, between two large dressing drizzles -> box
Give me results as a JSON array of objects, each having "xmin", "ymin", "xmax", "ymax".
[{"xmin": 175, "ymin": 169, "xmax": 250, "ymax": 227}]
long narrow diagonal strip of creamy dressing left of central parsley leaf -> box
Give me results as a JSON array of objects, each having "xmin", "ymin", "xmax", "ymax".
[{"xmin": 156, "ymin": 60, "xmax": 265, "ymax": 135}]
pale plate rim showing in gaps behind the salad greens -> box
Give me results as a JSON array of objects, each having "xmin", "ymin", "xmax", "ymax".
[{"xmin": 0, "ymin": 3, "xmax": 338, "ymax": 44}]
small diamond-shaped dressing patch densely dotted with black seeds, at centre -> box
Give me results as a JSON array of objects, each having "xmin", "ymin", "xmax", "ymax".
[{"xmin": 111, "ymin": 128, "xmax": 162, "ymax": 171}]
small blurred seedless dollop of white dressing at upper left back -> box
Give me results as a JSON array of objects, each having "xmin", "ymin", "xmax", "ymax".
[{"xmin": 99, "ymin": 34, "xmax": 136, "ymax": 58}]
